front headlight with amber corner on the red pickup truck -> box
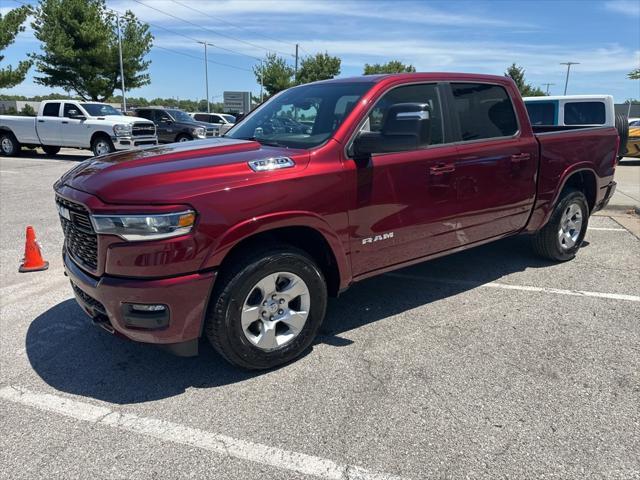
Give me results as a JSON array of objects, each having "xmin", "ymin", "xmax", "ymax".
[{"xmin": 91, "ymin": 210, "xmax": 196, "ymax": 242}]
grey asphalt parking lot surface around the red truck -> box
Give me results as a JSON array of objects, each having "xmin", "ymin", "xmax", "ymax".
[{"xmin": 0, "ymin": 148, "xmax": 640, "ymax": 480}]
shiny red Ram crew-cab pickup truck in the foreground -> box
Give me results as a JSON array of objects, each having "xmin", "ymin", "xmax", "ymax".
[{"xmin": 54, "ymin": 73, "xmax": 619, "ymax": 369}]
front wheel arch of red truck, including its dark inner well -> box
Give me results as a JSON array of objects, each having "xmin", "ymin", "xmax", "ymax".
[{"xmin": 203, "ymin": 212, "xmax": 351, "ymax": 296}]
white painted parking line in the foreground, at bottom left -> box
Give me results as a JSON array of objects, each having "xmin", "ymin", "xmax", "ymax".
[{"xmin": 0, "ymin": 386, "xmax": 402, "ymax": 480}]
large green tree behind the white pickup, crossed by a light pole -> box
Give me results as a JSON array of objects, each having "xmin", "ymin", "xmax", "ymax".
[{"xmin": 31, "ymin": 0, "xmax": 153, "ymax": 101}]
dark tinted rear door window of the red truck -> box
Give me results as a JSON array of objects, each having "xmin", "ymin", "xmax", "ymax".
[{"xmin": 451, "ymin": 83, "xmax": 518, "ymax": 140}]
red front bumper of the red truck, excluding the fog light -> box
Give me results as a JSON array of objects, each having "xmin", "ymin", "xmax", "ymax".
[{"xmin": 63, "ymin": 252, "xmax": 216, "ymax": 356}]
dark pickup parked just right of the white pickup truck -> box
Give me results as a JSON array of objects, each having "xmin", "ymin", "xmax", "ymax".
[{"xmin": 135, "ymin": 107, "xmax": 216, "ymax": 143}]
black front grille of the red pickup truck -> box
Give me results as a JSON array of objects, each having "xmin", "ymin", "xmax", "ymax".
[{"xmin": 56, "ymin": 197, "xmax": 98, "ymax": 270}]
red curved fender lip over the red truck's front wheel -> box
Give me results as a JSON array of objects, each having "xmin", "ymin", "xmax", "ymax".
[{"xmin": 202, "ymin": 211, "xmax": 351, "ymax": 289}]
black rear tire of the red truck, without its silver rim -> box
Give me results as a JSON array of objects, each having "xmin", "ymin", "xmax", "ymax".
[{"xmin": 533, "ymin": 189, "xmax": 589, "ymax": 262}]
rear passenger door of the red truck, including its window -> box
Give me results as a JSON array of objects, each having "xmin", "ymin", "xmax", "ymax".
[{"xmin": 449, "ymin": 83, "xmax": 538, "ymax": 243}]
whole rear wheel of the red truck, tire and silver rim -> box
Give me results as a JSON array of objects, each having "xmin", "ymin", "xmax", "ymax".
[{"xmin": 533, "ymin": 189, "xmax": 589, "ymax": 262}]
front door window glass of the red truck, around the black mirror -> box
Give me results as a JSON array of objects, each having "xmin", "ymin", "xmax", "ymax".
[{"xmin": 362, "ymin": 84, "xmax": 444, "ymax": 145}]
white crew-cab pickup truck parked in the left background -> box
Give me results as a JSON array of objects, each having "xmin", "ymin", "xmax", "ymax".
[{"xmin": 0, "ymin": 100, "xmax": 158, "ymax": 156}]
